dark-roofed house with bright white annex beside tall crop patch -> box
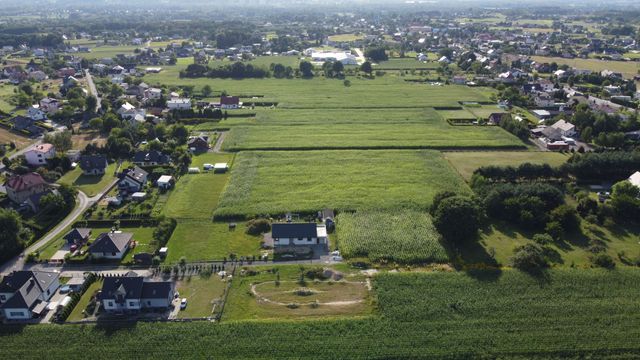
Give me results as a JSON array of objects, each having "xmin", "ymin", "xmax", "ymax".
[{"xmin": 271, "ymin": 223, "xmax": 327, "ymax": 247}]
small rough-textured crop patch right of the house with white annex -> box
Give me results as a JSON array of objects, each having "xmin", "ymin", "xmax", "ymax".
[{"xmin": 336, "ymin": 210, "xmax": 449, "ymax": 264}]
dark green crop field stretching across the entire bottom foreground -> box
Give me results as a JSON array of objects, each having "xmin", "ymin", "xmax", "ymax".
[{"xmin": 5, "ymin": 266, "xmax": 640, "ymax": 359}]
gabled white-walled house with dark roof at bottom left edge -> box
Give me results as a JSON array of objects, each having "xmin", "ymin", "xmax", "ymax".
[{"xmin": 0, "ymin": 271, "xmax": 60, "ymax": 320}]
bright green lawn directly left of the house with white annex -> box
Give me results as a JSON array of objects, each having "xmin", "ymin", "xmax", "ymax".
[{"xmin": 165, "ymin": 220, "xmax": 262, "ymax": 264}]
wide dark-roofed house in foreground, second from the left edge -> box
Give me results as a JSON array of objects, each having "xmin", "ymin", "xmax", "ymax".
[{"xmin": 100, "ymin": 272, "xmax": 175, "ymax": 313}]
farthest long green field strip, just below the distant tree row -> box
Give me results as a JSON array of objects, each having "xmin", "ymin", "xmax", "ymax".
[{"xmin": 144, "ymin": 73, "xmax": 496, "ymax": 109}]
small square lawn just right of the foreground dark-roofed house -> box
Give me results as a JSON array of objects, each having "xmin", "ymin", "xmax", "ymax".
[{"xmin": 176, "ymin": 274, "xmax": 227, "ymax": 318}]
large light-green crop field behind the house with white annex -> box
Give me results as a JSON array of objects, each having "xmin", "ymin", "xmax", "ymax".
[{"xmin": 215, "ymin": 150, "xmax": 469, "ymax": 217}]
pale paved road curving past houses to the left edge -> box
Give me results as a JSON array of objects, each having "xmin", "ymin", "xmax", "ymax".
[{"xmin": 0, "ymin": 178, "xmax": 118, "ymax": 274}]
